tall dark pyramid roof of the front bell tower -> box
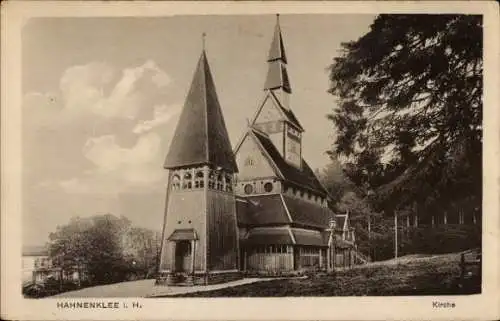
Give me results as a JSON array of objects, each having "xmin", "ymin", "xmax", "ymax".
[{"xmin": 164, "ymin": 49, "xmax": 238, "ymax": 173}]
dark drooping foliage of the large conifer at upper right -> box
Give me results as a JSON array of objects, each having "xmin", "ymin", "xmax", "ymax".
[{"xmin": 329, "ymin": 15, "xmax": 483, "ymax": 215}]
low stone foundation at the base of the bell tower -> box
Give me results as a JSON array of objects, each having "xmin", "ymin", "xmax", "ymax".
[{"xmin": 155, "ymin": 272, "xmax": 243, "ymax": 286}]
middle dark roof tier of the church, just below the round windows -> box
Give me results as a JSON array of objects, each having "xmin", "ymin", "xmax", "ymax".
[{"xmin": 236, "ymin": 194, "xmax": 333, "ymax": 229}]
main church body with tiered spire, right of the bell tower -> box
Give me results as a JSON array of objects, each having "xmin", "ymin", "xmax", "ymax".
[{"xmin": 235, "ymin": 16, "xmax": 334, "ymax": 274}]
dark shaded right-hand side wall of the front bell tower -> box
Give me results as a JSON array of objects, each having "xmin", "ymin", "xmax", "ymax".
[{"xmin": 207, "ymin": 190, "xmax": 238, "ymax": 271}]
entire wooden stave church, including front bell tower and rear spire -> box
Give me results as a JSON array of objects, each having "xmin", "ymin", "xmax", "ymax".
[{"xmin": 158, "ymin": 16, "xmax": 355, "ymax": 285}]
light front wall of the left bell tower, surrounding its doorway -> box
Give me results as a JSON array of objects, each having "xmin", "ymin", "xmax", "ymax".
[{"xmin": 160, "ymin": 189, "xmax": 206, "ymax": 271}]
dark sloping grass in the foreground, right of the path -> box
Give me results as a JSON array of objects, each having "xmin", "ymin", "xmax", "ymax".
[{"xmin": 171, "ymin": 253, "xmax": 481, "ymax": 297}]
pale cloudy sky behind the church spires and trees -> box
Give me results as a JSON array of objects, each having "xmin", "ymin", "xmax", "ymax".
[{"xmin": 22, "ymin": 14, "xmax": 374, "ymax": 245}]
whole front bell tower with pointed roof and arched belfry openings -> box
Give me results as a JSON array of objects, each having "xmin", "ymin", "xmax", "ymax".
[{"xmin": 158, "ymin": 49, "xmax": 239, "ymax": 285}]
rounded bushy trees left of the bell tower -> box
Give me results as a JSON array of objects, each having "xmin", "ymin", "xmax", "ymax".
[{"xmin": 49, "ymin": 214, "xmax": 157, "ymax": 284}]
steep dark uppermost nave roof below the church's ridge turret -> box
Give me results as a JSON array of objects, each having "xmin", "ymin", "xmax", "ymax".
[{"xmin": 252, "ymin": 129, "xmax": 327, "ymax": 196}]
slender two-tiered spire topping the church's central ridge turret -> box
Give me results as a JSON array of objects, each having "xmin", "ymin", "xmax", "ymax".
[{"xmin": 264, "ymin": 15, "xmax": 292, "ymax": 94}]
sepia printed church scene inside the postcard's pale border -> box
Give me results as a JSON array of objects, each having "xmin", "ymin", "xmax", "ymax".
[{"xmin": 2, "ymin": 1, "xmax": 498, "ymax": 317}]
